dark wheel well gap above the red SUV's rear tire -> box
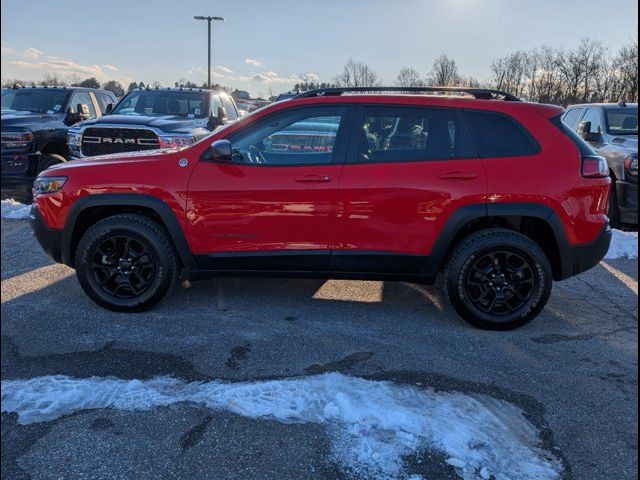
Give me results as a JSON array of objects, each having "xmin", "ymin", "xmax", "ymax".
[{"xmin": 446, "ymin": 215, "xmax": 562, "ymax": 279}]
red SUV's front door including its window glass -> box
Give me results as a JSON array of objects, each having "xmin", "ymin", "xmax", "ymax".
[{"xmin": 187, "ymin": 106, "xmax": 348, "ymax": 271}]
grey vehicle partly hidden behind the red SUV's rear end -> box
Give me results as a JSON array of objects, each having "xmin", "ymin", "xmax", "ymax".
[{"xmin": 562, "ymin": 102, "xmax": 638, "ymax": 227}]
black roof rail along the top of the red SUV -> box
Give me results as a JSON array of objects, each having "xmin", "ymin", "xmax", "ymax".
[{"xmin": 295, "ymin": 87, "xmax": 522, "ymax": 102}]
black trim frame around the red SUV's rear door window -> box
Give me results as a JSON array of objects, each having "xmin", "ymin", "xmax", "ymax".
[{"xmin": 345, "ymin": 103, "xmax": 480, "ymax": 165}]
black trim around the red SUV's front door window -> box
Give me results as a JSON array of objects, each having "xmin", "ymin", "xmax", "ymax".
[{"xmin": 219, "ymin": 103, "xmax": 353, "ymax": 168}]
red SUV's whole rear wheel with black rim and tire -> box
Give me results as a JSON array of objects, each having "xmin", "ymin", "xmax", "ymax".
[{"xmin": 444, "ymin": 228, "xmax": 553, "ymax": 330}]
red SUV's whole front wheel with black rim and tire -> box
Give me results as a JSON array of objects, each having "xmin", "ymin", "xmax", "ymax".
[{"xmin": 75, "ymin": 214, "xmax": 179, "ymax": 312}]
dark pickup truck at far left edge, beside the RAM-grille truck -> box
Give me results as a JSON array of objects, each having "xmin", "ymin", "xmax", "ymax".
[{"xmin": 2, "ymin": 85, "xmax": 116, "ymax": 184}]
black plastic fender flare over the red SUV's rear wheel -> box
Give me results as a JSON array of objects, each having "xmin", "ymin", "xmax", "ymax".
[{"xmin": 424, "ymin": 203, "xmax": 573, "ymax": 279}]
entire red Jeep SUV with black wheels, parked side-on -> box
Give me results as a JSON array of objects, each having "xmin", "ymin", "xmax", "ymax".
[{"xmin": 31, "ymin": 87, "xmax": 611, "ymax": 330}]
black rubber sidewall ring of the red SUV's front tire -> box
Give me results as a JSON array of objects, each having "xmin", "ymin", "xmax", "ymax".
[{"xmin": 75, "ymin": 218, "xmax": 172, "ymax": 311}]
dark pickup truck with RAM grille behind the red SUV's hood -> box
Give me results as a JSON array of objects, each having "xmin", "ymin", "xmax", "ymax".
[{"xmin": 68, "ymin": 87, "xmax": 239, "ymax": 159}]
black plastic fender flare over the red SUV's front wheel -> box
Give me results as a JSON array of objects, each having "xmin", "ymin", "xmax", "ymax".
[{"xmin": 61, "ymin": 193, "xmax": 197, "ymax": 271}]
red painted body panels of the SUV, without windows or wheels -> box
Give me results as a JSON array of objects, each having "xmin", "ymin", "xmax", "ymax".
[{"xmin": 35, "ymin": 95, "xmax": 610, "ymax": 262}]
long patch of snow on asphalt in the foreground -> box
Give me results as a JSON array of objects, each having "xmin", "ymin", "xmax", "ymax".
[{"xmin": 2, "ymin": 373, "xmax": 562, "ymax": 480}]
